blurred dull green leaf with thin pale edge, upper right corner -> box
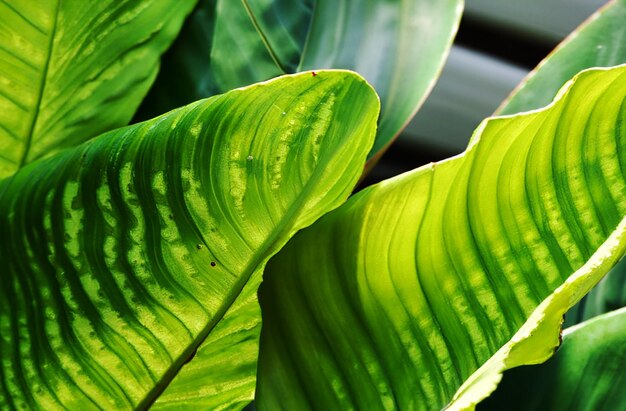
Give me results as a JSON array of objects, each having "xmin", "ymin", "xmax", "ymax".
[{"xmin": 496, "ymin": 0, "xmax": 626, "ymax": 114}]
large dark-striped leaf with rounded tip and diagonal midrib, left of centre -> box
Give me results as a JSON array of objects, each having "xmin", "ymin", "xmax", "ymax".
[{"xmin": 0, "ymin": 71, "xmax": 379, "ymax": 410}]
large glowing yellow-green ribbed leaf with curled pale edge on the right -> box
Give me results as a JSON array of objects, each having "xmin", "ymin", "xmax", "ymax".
[{"xmin": 257, "ymin": 66, "xmax": 626, "ymax": 410}]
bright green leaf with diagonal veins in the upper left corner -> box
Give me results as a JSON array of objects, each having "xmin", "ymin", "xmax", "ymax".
[{"xmin": 0, "ymin": 0, "xmax": 196, "ymax": 178}]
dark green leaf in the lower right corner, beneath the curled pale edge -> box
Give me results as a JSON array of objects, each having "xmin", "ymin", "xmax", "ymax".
[{"xmin": 478, "ymin": 308, "xmax": 626, "ymax": 411}]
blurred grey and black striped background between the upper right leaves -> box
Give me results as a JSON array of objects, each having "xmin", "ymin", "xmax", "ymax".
[{"xmin": 364, "ymin": 0, "xmax": 606, "ymax": 185}]
